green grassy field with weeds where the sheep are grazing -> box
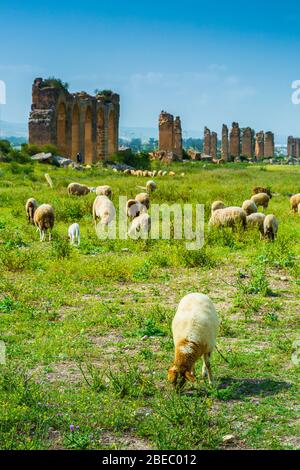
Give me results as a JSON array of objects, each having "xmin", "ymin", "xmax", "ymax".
[{"xmin": 0, "ymin": 163, "xmax": 300, "ymax": 449}]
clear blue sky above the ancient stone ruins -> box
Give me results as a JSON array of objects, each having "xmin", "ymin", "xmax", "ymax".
[{"xmin": 0, "ymin": 0, "xmax": 300, "ymax": 140}]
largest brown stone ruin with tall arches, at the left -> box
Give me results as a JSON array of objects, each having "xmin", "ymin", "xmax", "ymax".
[{"xmin": 29, "ymin": 78, "xmax": 120, "ymax": 164}]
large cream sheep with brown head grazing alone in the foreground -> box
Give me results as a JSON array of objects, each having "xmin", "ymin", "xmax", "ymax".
[{"xmin": 168, "ymin": 293, "xmax": 219, "ymax": 387}]
